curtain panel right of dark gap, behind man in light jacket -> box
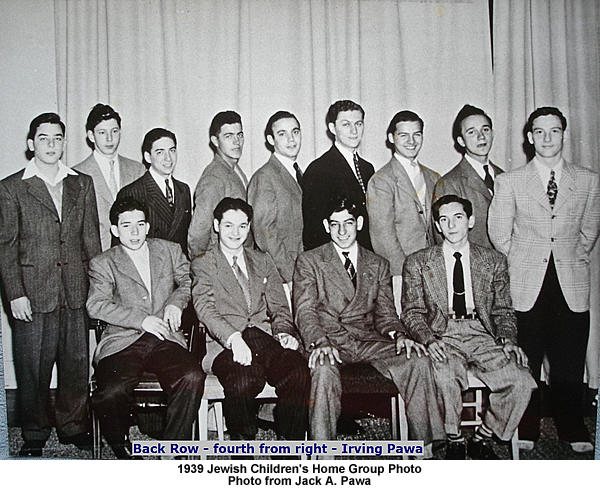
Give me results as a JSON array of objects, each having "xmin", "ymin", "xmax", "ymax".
[{"xmin": 493, "ymin": 0, "xmax": 600, "ymax": 388}]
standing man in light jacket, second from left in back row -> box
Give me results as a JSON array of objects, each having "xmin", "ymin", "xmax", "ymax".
[{"xmin": 74, "ymin": 104, "xmax": 145, "ymax": 251}]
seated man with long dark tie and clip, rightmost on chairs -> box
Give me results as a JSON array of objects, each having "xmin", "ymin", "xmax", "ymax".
[{"xmin": 402, "ymin": 195, "xmax": 536, "ymax": 460}]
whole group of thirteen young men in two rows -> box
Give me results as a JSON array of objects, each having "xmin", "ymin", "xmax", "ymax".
[{"xmin": 0, "ymin": 100, "xmax": 600, "ymax": 460}]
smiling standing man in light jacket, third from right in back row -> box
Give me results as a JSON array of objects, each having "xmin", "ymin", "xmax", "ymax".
[{"xmin": 367, "ymin": 110, "xmax": 440, "ymax": 313}]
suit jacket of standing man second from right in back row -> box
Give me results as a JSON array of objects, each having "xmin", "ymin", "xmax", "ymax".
[{"xmin": 433, "ymin": 157, "xmax": 503, "ymax": 248}]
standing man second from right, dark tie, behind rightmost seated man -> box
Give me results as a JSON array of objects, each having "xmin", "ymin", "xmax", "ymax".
[{"xmin": 433, "ymin": 105, "xmax": 502, "ymax": 248}]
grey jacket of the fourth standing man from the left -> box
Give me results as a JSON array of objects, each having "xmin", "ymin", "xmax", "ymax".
[{"xmin": 188, "ymin": 153, "xmax": 254, "ymax": 259}]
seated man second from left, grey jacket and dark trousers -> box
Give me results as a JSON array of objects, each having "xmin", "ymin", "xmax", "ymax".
[{"xmin": 192, "ymin": 197, "xmax": 310, "ymax": 440}]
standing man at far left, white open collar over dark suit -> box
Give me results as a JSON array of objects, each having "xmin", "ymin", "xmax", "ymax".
[{"xmin": 0, "ymin": 113, "xmax": 100, "ymax": 457}]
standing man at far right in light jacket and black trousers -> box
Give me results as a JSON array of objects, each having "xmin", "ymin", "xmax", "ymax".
[{"xmin": 488, "ymin": 107, "xmax": 600, "ymax": 452}]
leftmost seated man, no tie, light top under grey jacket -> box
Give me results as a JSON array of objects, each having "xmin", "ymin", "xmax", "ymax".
[{"xmin": 87, "ymin": 197, "xmax": 205, "ymax": 459}]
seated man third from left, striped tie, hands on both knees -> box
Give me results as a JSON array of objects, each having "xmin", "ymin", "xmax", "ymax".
[{"xmin": 293, "ymin": 193, "xmax": 444, "ymax": 444}]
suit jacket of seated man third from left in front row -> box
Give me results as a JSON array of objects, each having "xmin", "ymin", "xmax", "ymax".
[{"xmin": 293, "ymin": 242, "xmax": 403, "ymax": 349}]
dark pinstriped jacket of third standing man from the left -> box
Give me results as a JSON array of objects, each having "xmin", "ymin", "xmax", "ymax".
[{"xmin": 113, "ymin": 172, "xmax": 192, "ymax": 253}]
